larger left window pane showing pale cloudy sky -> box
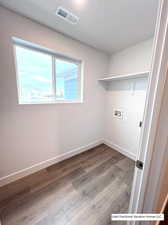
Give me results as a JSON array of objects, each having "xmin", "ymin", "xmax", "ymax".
[{"xmin": 16, "ymin": 46, "xmax": 54, "ymax": 103}]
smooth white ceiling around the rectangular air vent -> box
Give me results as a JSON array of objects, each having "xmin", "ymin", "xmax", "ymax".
[{"xmin": 0, "ymin": 0, "xmax": 158, "ymax": 53}]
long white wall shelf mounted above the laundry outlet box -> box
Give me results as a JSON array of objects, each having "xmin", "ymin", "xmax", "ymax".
[{"xmin": 98, "ymin": 71, "xmax": 149, "ymax": 81}]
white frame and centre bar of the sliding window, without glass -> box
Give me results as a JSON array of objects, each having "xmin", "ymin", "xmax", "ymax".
[{"xmin": 12, "ymin": 37, "xmax": 83, "ymax": 105}]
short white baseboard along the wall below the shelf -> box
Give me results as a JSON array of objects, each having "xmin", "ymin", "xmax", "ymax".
[{"xmin": 103, "ymin": 139, "xmax": 136, "ymax": 161}]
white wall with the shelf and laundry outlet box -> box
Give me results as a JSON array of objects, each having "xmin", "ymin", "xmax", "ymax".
[{"xmin": 105, "ymin": 39, "xmax": 153, "ymax": 158}]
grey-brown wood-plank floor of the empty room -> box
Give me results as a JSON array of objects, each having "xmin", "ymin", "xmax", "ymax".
[{"xmin": 0, "ymin": 145, "xmax": 134, "ymax": 225}]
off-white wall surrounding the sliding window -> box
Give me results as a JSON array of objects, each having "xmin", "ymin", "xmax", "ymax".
[{"xmin": 0, "ymin": 8, "xmax": 108, "ymax": 185}]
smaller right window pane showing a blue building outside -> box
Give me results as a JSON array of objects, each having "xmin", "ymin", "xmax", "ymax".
[{"xmin": 56, "ymin": 59, "xmax": 78, "ymax": 100}]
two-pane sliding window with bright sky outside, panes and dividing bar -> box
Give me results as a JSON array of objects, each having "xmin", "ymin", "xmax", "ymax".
[{"xmin": 14, "ymin": 39, "xmax": 81, "ymax": 104}]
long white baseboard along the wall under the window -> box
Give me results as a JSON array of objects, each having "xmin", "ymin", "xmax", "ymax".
[{"xmin": 0, "ymin": 139, "xmax": 103, "ymax": 187}]
